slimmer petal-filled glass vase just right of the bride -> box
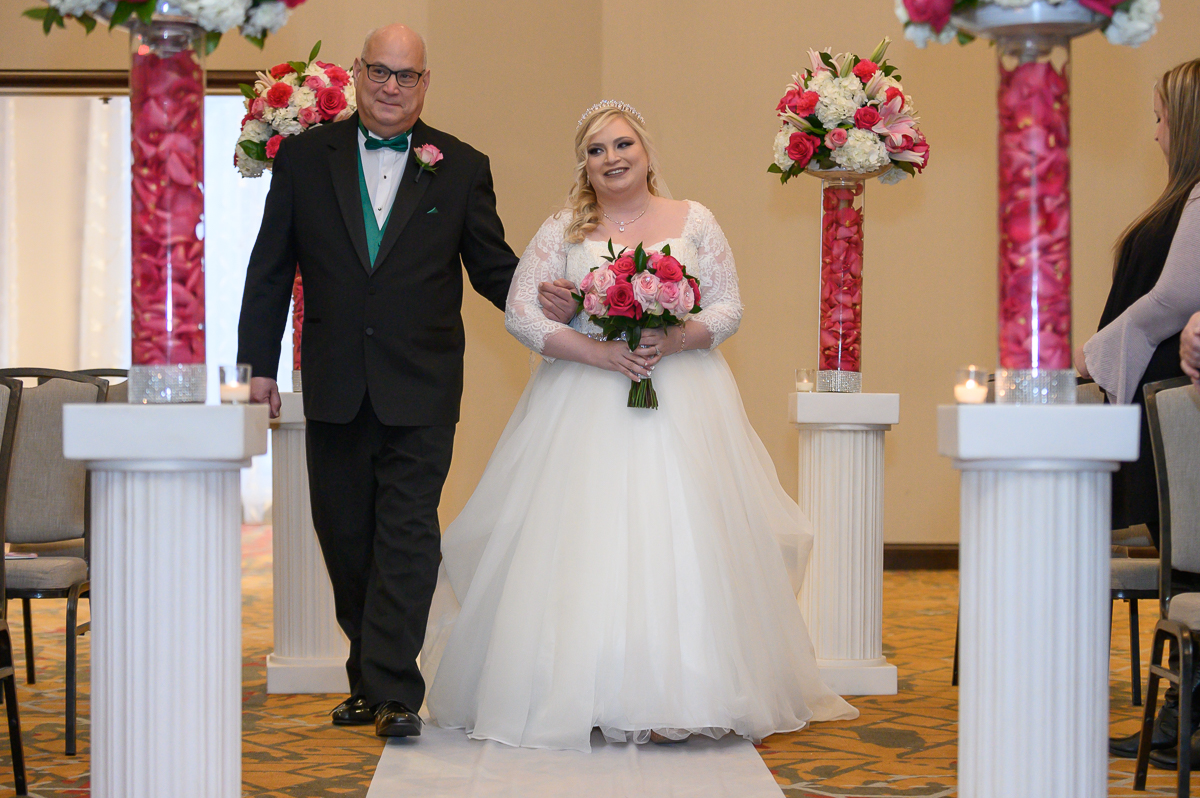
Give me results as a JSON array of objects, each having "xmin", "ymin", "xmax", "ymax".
[{"xmin": 817, "ymin": 173, "xmax": 866, "ymax": 394}]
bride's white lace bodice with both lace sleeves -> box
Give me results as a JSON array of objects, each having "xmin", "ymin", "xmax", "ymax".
[{"xmin": 504, "ymin": 200, "xmax": 742, "ymax": 354}]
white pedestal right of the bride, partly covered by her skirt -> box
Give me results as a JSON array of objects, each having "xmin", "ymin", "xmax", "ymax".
[{"xmin": 788, "ymin": 394, "xmax": 900, "ymax": 696}]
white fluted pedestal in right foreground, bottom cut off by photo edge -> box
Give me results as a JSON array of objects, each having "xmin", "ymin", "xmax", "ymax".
[{"xmin": 937, "ymin": 404, "xmax": 1139, "ymax": 798}]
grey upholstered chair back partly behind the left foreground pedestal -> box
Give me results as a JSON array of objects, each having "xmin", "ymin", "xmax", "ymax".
[{"xmin": 0, "ymin": 368, "xmax": 108, "ymax": 544}]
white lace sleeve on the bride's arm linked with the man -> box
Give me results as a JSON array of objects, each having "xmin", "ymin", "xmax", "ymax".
[{"xmin": 504, "ymin": 214, "xmax": 570, "ymax": 354}]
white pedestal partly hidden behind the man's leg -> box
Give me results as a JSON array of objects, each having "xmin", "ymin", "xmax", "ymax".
[{"xmin": 266, "ymin": 394, "xmax": 350, "ymax": 694}]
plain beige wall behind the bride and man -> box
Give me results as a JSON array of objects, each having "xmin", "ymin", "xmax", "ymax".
[{"xmin": 0, "ymin": 0, "xmax": 1200, "ymax": 542}]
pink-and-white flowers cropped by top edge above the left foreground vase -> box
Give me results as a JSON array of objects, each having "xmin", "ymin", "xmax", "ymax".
[{"xmin": 24, "ymin": 0, "xmax": 305, "ymax": 53}]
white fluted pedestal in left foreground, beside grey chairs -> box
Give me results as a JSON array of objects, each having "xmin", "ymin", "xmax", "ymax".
[{"xmin": 62, "ymin": 404, "xmax": 266, "ymax": 798}]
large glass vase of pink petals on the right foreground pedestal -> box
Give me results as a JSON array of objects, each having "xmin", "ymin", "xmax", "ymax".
[{"xmin": 996, "ymin": 31, "xmax": 1075, "ymax": 404}]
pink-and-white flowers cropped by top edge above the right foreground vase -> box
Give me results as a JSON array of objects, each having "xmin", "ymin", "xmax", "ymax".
[{"xmin": 895, "ymin": 0, "xmax": 1163, "ymax": 47}]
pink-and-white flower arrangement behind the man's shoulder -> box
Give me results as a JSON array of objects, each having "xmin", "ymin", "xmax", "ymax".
[{"xmin": 234, "ymin": 42, "xmax": 355, "ymax": 178}]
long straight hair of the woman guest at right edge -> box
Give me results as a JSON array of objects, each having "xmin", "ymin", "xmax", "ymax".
[{"xmin": 1114, "ymin": 59, "xmax": 1200, "ymax": 271}]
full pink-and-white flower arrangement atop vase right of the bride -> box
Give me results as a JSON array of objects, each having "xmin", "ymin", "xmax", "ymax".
[{"xmin": 767, "ymin": 38, "xmax": 929, "ymax": 182}]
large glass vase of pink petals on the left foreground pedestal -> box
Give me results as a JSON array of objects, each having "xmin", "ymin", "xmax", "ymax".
[{"xmin": 130, "ymin": 17, "xmax": 205, "ymax": 403}]
